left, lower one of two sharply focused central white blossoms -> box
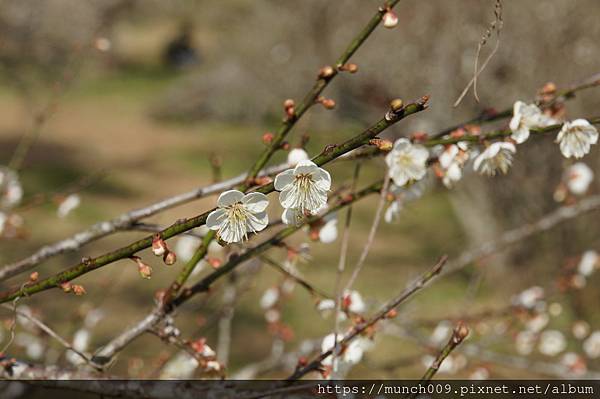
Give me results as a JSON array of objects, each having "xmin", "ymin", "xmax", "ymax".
[{"xmin": 206, "ymin": 190, "xmax": 269, "ymax": 243}]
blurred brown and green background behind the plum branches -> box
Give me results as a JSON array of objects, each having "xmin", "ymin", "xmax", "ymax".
[{"xmin": 0, "ymin": 0, "xmax": 600, "ymax": 384}]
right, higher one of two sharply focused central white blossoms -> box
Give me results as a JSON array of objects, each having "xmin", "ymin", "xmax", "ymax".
[{"xmin": 275, "ymin": 160, "xmax": 331, "ymax": 224}]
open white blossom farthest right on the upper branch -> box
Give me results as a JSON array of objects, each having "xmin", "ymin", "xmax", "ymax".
[{"xmin": 556, "ymin": 119, "xmax": 598, "ymax": 158}]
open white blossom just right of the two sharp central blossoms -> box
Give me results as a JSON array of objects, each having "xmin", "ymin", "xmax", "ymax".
[{"xmin": 385, "ymin": 138, "xmax": 429, "ymax": 187}]
